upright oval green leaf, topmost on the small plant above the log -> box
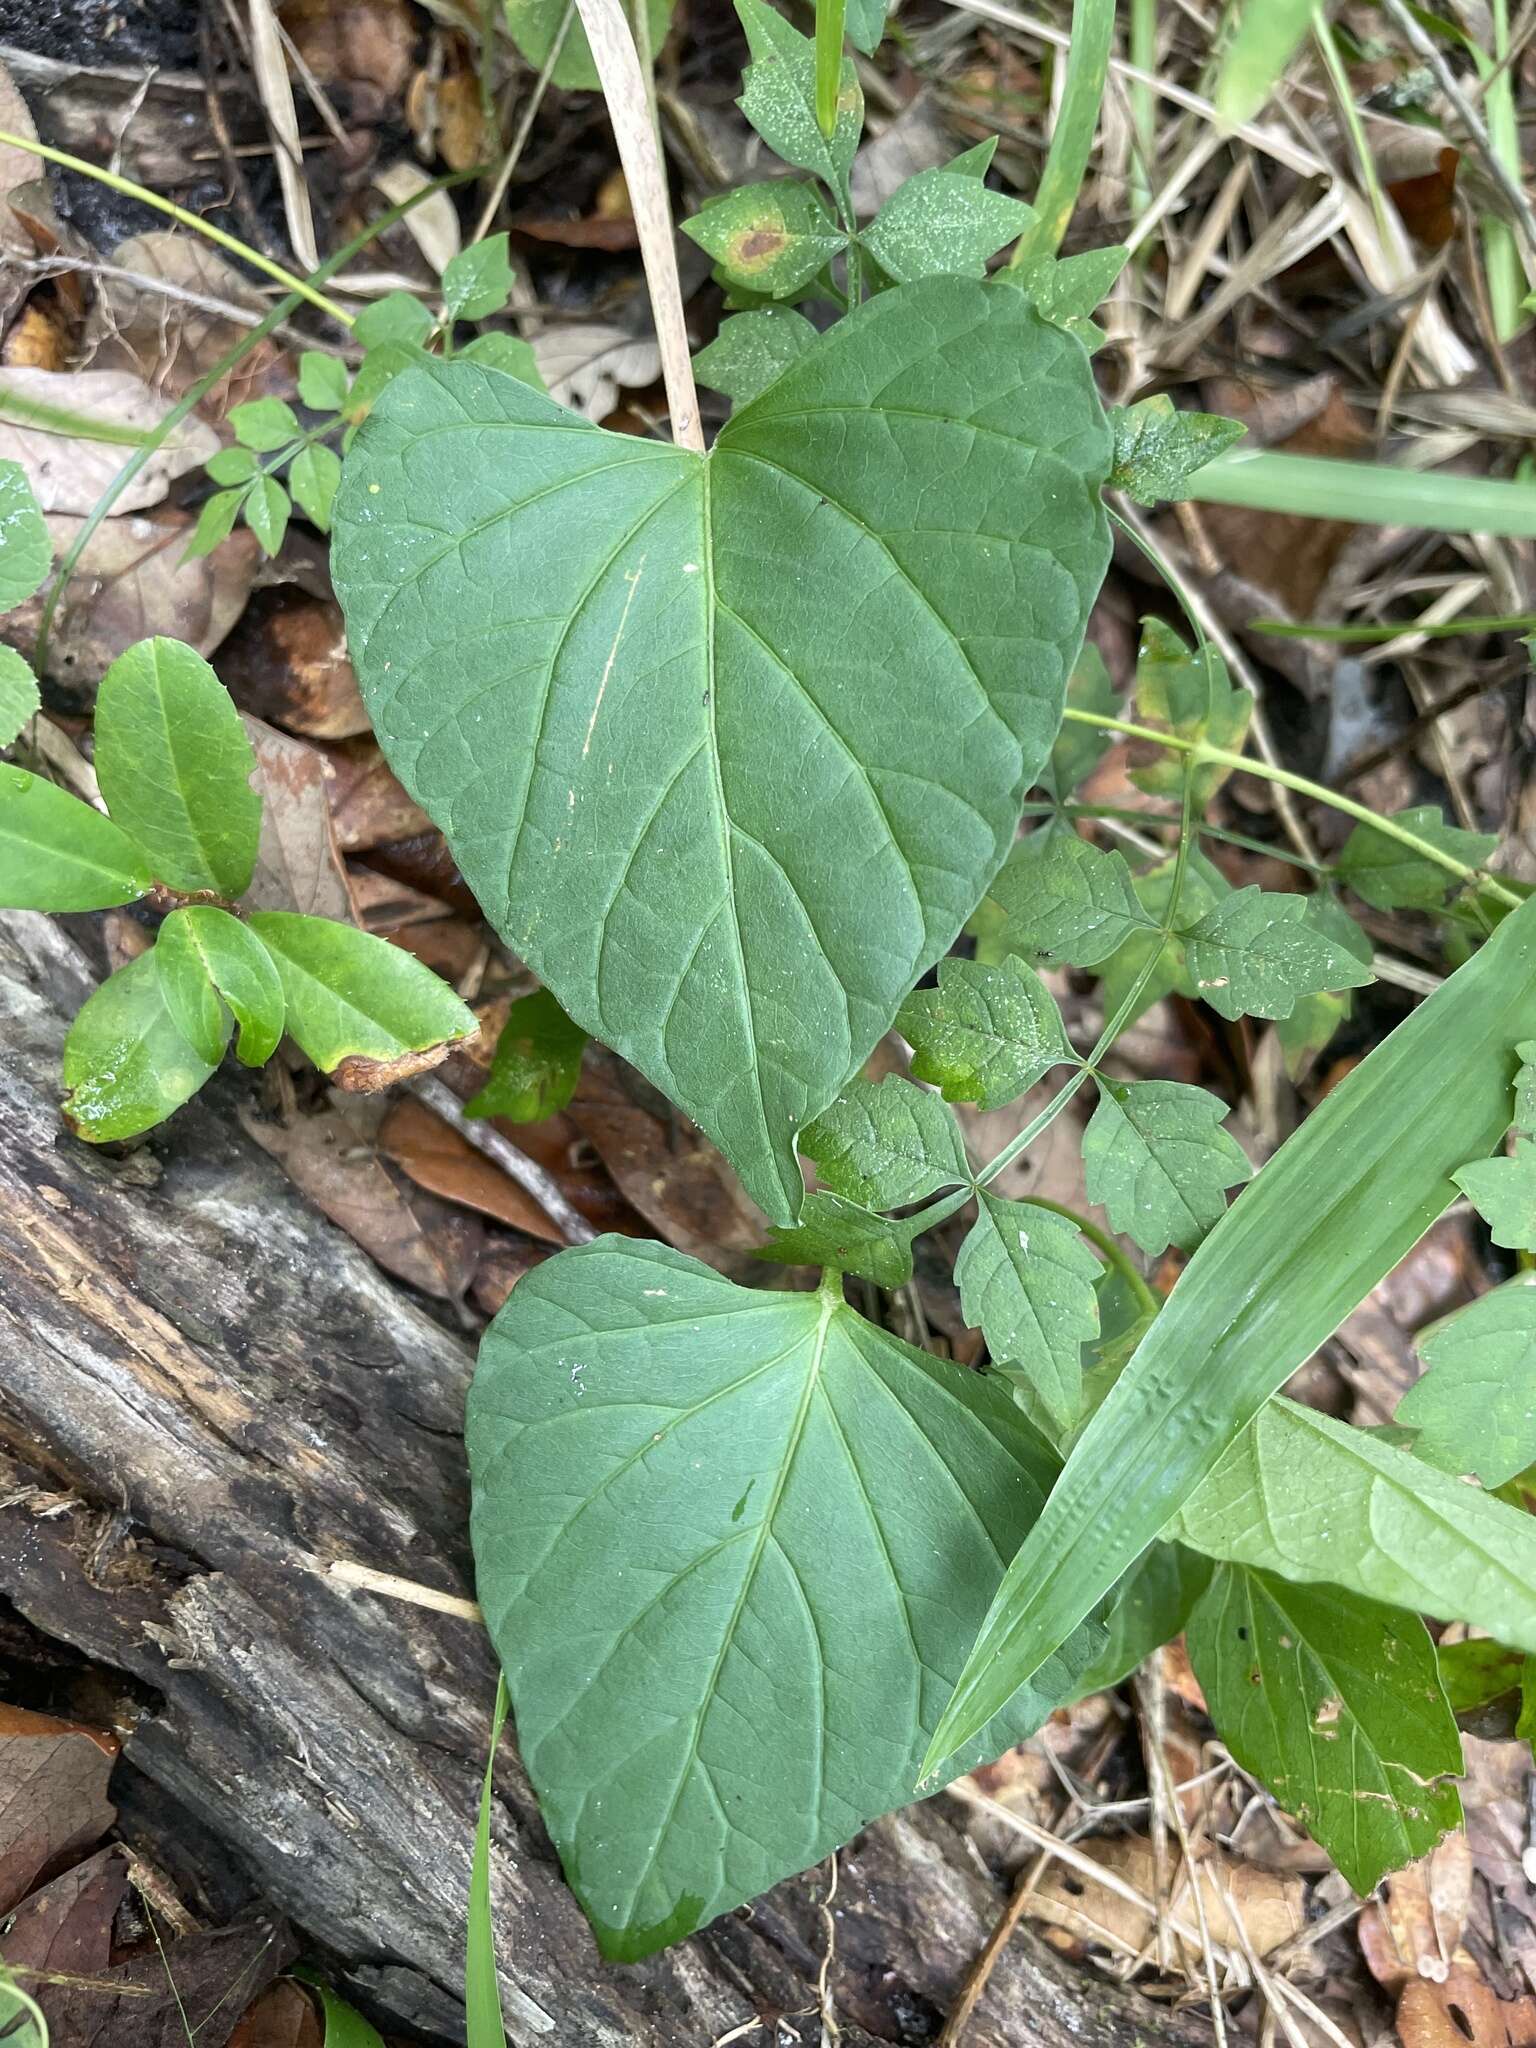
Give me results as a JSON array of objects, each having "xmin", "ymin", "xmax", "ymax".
[{"xmin": 96, "ymin": 639, "xmax": 262, "ymax": 897}]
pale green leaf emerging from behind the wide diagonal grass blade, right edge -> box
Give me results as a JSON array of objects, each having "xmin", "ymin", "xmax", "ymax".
[{"xmin": 1179, "ymin": 1400, "xmax": 1536, "ymax": 1651}]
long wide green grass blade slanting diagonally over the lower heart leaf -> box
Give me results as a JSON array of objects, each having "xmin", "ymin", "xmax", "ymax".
[{"xmin": 928, "ymin": 903, "xmax": 1536, "ymax": 1763}]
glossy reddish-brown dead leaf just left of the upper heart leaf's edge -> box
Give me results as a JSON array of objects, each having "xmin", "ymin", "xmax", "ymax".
[{"xmin": 219, "ymin": 584, "xmax": 369, "ymax": 739}]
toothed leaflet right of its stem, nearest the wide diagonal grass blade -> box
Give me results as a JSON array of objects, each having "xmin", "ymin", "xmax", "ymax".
[{"xmin": 1083, "ymin": 1079, "xmax": 1253, "ymax": 1257}]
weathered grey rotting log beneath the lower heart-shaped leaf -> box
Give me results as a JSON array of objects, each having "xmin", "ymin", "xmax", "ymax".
[{"xmin": 0, "ymin": 913, "xmax": 1208, "ymax": 2048}]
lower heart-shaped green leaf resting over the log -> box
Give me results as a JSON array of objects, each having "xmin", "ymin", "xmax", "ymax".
[{"xmin": 467, "ymin": 1237, "xmax": 1096, "ymax": 1960}]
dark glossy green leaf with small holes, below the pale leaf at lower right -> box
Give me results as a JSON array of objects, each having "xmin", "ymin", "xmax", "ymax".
[{"xmin": 1188, "ymin": 1565, "xmax": 1462, "ymax": 1896}]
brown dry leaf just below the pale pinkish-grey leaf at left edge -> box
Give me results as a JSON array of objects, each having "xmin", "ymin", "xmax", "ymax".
[{"xmin": 4, "ymin": 507, "xmax": 260, "ymax": 705}]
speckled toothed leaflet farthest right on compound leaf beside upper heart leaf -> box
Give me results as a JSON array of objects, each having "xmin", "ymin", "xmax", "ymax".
[{"xmin": 1184, "ymin": 885, "xmax": 1372, "ymax": 1020}]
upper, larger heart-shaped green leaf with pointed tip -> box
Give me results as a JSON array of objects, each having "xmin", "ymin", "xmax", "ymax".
[{"xmin": 334, "ymin": 279, "xmax": 1110, "ymax": 1221}]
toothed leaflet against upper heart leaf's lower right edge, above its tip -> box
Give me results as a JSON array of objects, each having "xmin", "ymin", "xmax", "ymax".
[{"xmin": 897, "ymin": 954, "xmax": 1077, "ymax": 1110}]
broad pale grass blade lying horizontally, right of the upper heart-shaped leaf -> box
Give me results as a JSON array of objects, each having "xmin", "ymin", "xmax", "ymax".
[{"xmin": 1188, "ymin": 449, "xmax": 1536, "ymax": 541}]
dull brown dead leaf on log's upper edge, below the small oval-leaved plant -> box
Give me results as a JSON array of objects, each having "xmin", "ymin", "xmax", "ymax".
[{"xmin": 240, "ymin": 1104, "xmax": 485, "ymax": 1300}]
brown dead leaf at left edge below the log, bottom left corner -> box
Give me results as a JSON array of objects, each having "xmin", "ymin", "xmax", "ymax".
[{"xmin": 0, "ymin": 1704, "xmax": 117, "ymax": 1913}]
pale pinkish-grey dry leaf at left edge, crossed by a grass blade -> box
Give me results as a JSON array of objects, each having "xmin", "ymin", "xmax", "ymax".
[{"xmin": 0, "ymin": 369, "xmax": 219, "ymax": 516}]
